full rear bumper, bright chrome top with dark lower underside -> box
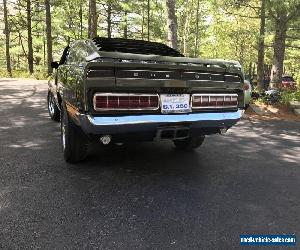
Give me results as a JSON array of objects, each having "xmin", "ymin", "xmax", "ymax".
[{"xmin": 79, "ymin": 110, "xmax": 243, "ymax": 134}]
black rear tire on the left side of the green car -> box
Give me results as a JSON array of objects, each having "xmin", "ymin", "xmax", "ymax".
[{"xmin": 60, "ymin": 105, "xmax": 88, "ymax": 163}]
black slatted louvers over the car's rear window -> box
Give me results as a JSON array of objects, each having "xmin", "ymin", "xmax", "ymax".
[{"xmin": 93, "ymin": 37, "xmax": 183, "ymax": 57}]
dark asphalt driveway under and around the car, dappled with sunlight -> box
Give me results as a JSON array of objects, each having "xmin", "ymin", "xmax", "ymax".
[{"xmin": 0, "ymin": 81, "xmax": 300, "ymax": 249}]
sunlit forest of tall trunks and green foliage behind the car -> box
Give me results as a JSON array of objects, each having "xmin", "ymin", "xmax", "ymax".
[{"xmin": 0, "ymin": 0, "xmax": 300, "ymax": 87}]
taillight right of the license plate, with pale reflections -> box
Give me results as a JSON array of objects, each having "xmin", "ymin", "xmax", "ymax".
[{"xmin": 192, "ymin": 94, "xmax": 238, "ymax": 109}]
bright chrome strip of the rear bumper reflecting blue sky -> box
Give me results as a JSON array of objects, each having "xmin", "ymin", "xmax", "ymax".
[{"xmin": 87, "ymin": 110, "xmax": 242, "ymax": 126}]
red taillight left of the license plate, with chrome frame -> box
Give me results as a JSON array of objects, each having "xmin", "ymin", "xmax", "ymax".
[{"xmin": 94, "ymin": 93, "xmax": 159, "ymax": 111}]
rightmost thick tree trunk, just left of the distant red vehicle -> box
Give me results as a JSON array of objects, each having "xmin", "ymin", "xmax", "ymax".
[{"xmin": 271, "ymin": 18, "xmax": 287, "ymax": 88}]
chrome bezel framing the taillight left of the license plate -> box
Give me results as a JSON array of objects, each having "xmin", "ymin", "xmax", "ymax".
[{"xmin": 93, "ymin": 93, "xmax": 160, "ymax": 111}]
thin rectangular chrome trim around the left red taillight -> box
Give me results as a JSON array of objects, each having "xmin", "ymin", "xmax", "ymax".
[{"xmin": 93, "ymin": 93, "xmax": 160, "ymax": 111}]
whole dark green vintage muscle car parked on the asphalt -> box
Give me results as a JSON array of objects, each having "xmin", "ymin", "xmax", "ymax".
[{"xmin": 48, "ymin": 37, "xmax": 244, "ymax": 163}]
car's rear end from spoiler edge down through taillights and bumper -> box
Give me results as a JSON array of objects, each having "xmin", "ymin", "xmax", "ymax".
[{"xmin": 80, "ymin": 57, "xmax": 244, "ymax": 142}]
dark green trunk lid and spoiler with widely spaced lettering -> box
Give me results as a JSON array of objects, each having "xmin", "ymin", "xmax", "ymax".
[{"xmin": 86, "ymin": 52, "xmax": 243, "ymax": 89}]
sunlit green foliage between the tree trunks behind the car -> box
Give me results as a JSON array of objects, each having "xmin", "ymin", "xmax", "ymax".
[{"xmin": 0, "ymin": 0, "xmax": 300, "ymax": 80}]
